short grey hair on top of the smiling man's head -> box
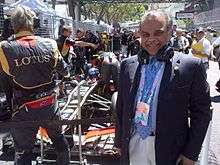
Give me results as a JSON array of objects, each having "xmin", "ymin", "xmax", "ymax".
[{"xmin": 140, "ymin": 10, "xmax": 173, "ymax": 31}]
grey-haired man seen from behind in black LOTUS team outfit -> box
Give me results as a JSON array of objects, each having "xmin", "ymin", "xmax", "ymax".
[{"xmin": 0, "ymin": 6, "xmax": 70, "ymax": 165}]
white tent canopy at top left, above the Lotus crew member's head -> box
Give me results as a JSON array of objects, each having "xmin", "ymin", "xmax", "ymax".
[{"xmin": 9, "ymin": 0, "xmax": 56, "ymax": 15}]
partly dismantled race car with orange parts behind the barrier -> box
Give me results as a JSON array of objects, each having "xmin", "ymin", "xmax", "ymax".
[{"xmin": 0, "ymin": 77, "xmax": 118, "ymax": 164}]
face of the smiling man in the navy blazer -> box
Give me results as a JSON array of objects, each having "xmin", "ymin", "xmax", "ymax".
[{"xmin": 140, "ymin": 16, "xmax": 171, "ymax": 55}]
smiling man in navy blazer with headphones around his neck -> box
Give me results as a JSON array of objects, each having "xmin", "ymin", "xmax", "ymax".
[{"xmin": 115, "ymin": 11, "xmax": 211, "ymax": 165}]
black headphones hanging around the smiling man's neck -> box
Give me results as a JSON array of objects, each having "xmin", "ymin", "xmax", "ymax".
[{"xmin": 138, "ymin": 44, "xmax": 174, "ymax": 65}]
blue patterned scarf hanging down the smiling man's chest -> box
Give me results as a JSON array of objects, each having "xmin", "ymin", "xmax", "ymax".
[{"xmin": 134, "ymin": 57, "xmax": 164, "ymax": 139}]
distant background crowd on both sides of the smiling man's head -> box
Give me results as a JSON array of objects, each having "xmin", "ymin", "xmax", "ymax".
[{"xmin": 58, "ymin": 18, "xmax": 220, "ymax": 85}]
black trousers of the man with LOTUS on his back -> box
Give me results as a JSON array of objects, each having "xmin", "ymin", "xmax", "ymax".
[{"xmin": 11, "ymin": 101, "xmax": 70, "ymax": 165}]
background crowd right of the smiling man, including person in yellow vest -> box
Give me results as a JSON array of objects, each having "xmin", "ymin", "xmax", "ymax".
[{"xmin": 170, "ymin": 24, "xmax": 220, "ymax": 92}]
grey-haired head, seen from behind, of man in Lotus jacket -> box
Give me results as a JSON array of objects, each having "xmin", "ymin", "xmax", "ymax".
[{"xmin": 11, "ymin": 5, "xmax": 36, "ymax": 33}]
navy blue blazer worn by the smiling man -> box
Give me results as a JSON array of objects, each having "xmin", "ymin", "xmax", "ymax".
[{"xmin": 115, "ymin": 53, "xmax": 211, "ymax": 165}]
